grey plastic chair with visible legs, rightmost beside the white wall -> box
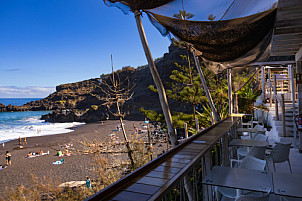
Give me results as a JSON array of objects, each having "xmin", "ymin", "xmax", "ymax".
[{"xmin": 268, "ymin": 142, "xmax": 293, "ymax": 173}]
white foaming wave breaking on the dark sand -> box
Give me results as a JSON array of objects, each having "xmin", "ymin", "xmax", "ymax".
[{"xmin": 0, "ymin": 121, "xmax": 85, "ymax": 143}]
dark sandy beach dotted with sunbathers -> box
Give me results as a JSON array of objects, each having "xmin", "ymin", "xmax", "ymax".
[{"xmin": 0, "ymin": 120, "xmax": 168, "ymax": 193}]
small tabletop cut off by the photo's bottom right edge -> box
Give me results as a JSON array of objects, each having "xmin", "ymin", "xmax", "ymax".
[{"xmin": 273, "ymin": 172, "xmax": 302, "ymax": 198}]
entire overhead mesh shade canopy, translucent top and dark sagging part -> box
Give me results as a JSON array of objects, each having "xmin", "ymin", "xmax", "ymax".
[{"xmin": 105, "ymin": 0, "xmax": 277, "ymax": 73}]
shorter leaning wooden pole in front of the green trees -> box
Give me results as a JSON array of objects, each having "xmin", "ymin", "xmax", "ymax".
[{"xmin": 192, "ymin": 51, "xmax": 220, "ymax": 123}]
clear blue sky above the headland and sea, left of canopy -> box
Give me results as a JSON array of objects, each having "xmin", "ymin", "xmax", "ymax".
[{"xmin": 0, "ymin": 0, "xmax": 170, "ymax": 98}]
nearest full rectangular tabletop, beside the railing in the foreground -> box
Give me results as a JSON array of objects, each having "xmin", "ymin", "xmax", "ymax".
[{"xmin": 202, "ymin": 166, "xmax": 273, "ymax": 193}]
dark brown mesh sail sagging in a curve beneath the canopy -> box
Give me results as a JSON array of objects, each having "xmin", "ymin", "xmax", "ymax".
[{"xmin": 148, "ymin": 9, "xmax": 276, "ymax": 62}]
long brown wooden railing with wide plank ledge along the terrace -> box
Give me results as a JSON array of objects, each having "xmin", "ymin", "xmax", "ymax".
[{"xmin": 86, "ymin": 117, "xmax": 241, "ymax": 201}]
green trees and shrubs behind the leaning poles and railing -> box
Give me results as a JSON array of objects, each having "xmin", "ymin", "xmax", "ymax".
[{"xmin": 140, "ymin": 54, "xmax": 261, "ymax": 134}]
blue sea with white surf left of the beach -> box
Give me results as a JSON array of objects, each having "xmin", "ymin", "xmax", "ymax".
[{"xmin": 0, "ymin": 98, "xmax": 84, "ymax": 143}]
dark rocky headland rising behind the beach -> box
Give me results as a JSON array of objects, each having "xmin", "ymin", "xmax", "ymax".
[{"xmin": 0, "ymin": 46, "xmax": 190, "ymax": 122}]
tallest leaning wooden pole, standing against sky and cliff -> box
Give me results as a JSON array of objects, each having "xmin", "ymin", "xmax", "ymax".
[{"xmin": 134, "ymin": 11, "xmax": 178, "ymax": 147}]
